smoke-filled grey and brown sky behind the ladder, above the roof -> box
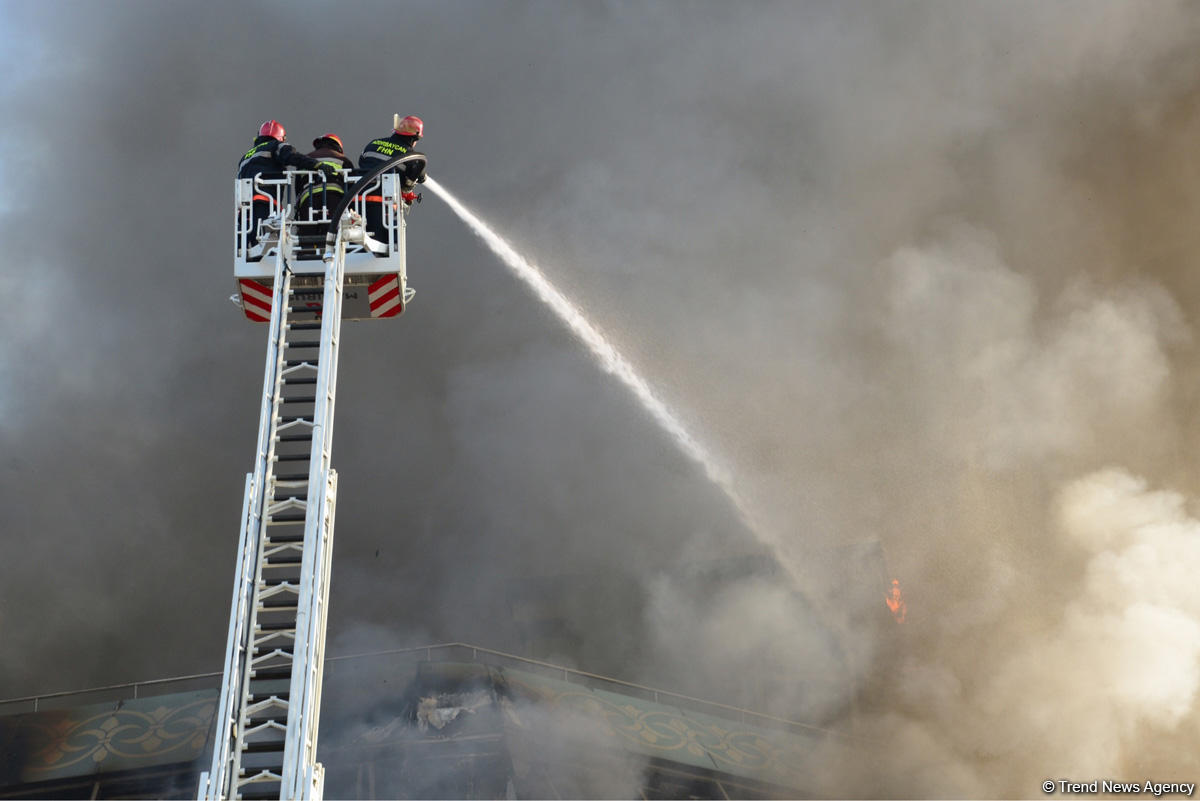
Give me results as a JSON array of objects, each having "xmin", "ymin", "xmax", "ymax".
[{"xmin": 0, "ymin": 0, "xmax": 1200, "ymax": 797}]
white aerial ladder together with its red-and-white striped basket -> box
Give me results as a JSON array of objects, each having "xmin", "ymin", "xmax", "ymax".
[{"xmin": 198, "ymin": 153, "xmax": 425, "ymax": 799}]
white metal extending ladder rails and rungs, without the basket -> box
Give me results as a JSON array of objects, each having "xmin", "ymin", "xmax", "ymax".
[{"xmin": 199, "ymin": 209, "xmax": 346, "ymax": 799}]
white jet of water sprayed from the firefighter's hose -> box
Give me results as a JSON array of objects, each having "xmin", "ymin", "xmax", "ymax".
[{"xmin": 425, "ymin": 177, "xmax": 774, "ymax": 556}]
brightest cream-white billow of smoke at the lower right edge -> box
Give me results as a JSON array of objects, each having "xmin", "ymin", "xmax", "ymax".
[{"xmin": 982, "ymin": 469, "xmax": 1200, "ymax": 781}]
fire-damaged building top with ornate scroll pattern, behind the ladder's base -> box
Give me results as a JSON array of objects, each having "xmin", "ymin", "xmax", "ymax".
[{"xmin": 0, "ymin": 644, "xmax": 856, "ymax": 797}]
